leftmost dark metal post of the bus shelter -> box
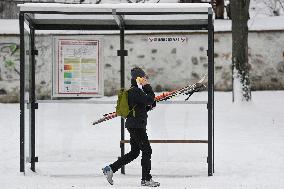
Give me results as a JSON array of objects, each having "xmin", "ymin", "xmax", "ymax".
[{"xmin": 19, "ymin": 13, "xmax": 25, "ymax": 172}]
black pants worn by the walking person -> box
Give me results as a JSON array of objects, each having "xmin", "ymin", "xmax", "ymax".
[{"xmin": 110, "ymin": 128, "xmax": 152, "ymax": 180}]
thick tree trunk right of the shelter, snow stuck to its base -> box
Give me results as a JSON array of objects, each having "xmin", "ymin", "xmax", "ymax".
[{"xmin": 231, "ymin": 0, "xmax": 251, "ymax": 101}]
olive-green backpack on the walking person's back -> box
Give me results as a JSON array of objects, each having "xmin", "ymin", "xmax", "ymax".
[{"xmin": 115, "ymin": 89, "xmax": 135, "ymax": 118}]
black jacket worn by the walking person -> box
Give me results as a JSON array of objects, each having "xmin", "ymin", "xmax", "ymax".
[{"xmin": 125, "ymin": 80, "xmax": 155, "ymax": 128}]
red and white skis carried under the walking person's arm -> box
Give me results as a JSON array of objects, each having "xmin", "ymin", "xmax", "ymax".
[{"xmin": 93, "ymin": 75, "xmax": 206, "ymax": 125}]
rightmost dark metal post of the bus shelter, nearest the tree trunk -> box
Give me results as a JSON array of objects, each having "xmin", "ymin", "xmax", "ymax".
[{"xmin": 207, "ymin": 8, "xmax": 214, "ymax": 176}]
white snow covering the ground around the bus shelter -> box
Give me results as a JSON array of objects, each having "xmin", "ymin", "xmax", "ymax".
[{"xmin": 0, "ymin": 91, "xmax": 284, "ymax": 189}]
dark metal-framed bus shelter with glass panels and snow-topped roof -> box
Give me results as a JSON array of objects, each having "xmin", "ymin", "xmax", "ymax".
[{"xmin": 18, "ymin": 3, "xmax": 214, "ymax": 176}]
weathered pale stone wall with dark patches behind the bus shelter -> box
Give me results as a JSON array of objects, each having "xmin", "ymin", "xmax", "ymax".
[{"xmin": 0, "ymin": 31, "xmax": 284, "ymax": 102}]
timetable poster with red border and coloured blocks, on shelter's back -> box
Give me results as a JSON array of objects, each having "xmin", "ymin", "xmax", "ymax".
[{"xmin": 57, "ymin": 39, "xmax": 100, "ymax": 96}]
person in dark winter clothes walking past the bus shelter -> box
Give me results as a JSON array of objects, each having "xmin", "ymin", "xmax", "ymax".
[{"xmin": 103, "ymin": 67, "xmax": 160, "ymax": 187}]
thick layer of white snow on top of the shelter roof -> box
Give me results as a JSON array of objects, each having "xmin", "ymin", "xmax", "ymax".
[{"xmin": 18, "ymin": 3, "xmax": 211, "ymax": 14}]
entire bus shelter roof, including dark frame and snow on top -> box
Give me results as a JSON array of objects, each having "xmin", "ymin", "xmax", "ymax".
[{"xmin": 18, "ymin": 3, "xmax": 213, "ymax": 30}]
